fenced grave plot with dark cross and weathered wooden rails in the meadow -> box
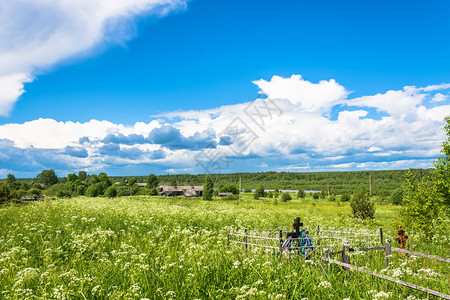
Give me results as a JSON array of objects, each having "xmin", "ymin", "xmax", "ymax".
[{"xmin": 228, "ymin": 218, "xmax": 450, "ymax": 300}]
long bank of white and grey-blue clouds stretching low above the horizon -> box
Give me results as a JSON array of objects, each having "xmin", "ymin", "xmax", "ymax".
[{"xmin": 0, "ymin": 75, "xmax": 450, "ymax": 176}]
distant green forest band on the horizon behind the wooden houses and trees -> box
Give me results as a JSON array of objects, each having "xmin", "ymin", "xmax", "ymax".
[{"xmin": 110, "ymin": 169, "xmax": 431, "ymax": 196}]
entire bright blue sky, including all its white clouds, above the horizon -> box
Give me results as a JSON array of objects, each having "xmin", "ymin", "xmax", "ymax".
[{"xmin": 0, "ymin": 0, "xmax": 450, "ymax": 177}]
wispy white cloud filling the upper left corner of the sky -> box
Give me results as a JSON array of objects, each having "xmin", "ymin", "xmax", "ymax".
[{"xmin": 0, "ymin": 0, "xmax": 187, "ymax": 116}]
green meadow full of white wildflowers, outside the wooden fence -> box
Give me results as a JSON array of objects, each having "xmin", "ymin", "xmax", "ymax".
[{"xmin": 0, "ymin": 195, "xmax": 450, "ymax": 299}]
